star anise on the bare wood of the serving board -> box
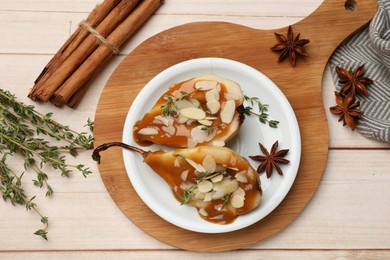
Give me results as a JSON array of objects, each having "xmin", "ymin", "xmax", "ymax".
[{"xmin": 271, "ymin": 25, "xmax": 310, "ymax": 66}]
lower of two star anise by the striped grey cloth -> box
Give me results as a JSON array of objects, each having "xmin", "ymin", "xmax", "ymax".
[{"xmin": 330, "ymin": 92, "xmax": 363, "ymax": 131}]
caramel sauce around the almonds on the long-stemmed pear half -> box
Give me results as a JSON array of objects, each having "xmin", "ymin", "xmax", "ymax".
[{"xmin": 145, "ymin": 147, "xmax": 261, "ymax": 224}]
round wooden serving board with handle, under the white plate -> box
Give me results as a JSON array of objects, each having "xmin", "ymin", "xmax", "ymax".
[{"xmin": 94, "ymin": 0, "xmax": 377, "ymax": 251}]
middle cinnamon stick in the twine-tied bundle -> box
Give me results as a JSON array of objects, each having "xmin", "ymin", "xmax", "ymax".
[{"xmin": 29, "ymin": 0, "xmax": 139, "ymax": 101}]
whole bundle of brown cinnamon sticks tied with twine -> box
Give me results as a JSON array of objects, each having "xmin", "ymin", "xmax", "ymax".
[{"xmin": 28, "ymin": 0, "xmax": 163, "ymax": 107}]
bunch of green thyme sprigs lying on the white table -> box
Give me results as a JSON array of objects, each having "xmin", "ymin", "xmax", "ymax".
[{"xmin": 0, "ymin": 89, "xmax": 93, "ymax": 240}]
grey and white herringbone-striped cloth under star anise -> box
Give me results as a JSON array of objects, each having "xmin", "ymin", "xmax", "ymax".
[{"xmin": 329, "ymin": 0, "xmax": 390, "ymax": 142}]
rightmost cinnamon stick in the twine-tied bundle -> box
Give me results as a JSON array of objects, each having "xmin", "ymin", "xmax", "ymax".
[{"xmin": 52, "ymin": 0, "xmax": 163, "ymax": 106}]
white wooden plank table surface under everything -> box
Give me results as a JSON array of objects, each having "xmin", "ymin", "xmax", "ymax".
[{"xmin": 0, "ymin": 0, "xmax": 390, "ymax": 259}]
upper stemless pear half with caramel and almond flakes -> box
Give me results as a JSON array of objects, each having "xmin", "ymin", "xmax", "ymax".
[{"xmin": 133, "ymin": 74, "xmax": 244, "ymax": 148}]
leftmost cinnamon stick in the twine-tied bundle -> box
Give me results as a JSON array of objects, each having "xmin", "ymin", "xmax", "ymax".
[{"xmin": 29, "ymin": 0, "xmax": 121, "ymax": 94}]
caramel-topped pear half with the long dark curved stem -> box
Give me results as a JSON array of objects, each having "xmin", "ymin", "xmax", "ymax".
[{"xmin": 92, "ymin": 143, "xmax": 262, "ymax": 224}]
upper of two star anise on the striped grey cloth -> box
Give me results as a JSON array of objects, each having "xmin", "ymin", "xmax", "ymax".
[{"xmin": 336, "ymin": 64, "xmax": 373, "ymax": 96}]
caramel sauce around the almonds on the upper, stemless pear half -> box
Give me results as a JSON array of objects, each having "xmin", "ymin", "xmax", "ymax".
[{"xmin": 133, "ymin": 78, "xmax": 237, "ymax": 147}]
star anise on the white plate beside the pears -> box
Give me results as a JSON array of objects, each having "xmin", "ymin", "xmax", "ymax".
[{"xmin": 249, "ymin": 141, "xmax": 290, "ymax": 178}]
